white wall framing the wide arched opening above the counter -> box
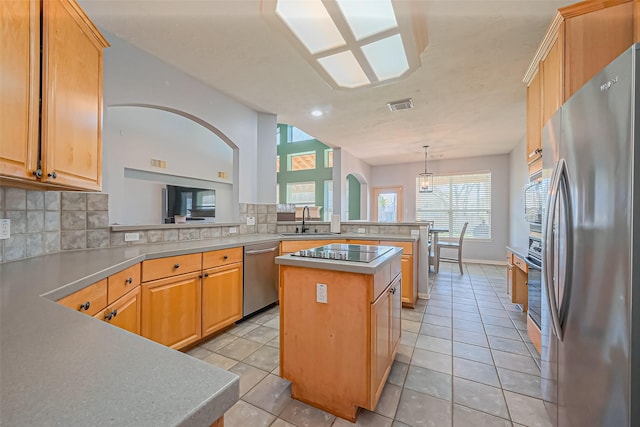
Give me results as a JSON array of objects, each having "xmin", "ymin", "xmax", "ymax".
[{"xmin": 103, "ymin": 31, "xmax": 275, "ymax": 216}]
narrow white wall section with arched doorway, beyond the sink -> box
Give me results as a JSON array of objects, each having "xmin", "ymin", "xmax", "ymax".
[{"xmin": 333, "ymin": 148, "xmax": 372, "ymax": 221}]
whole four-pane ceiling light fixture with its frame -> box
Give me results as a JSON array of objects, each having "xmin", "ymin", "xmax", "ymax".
[{"xmin": 262, "ymin": 0, "xmax": 427, "ymax": 89}]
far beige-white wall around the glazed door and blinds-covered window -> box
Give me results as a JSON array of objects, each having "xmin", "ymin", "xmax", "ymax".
[{"xmin": 371, "ymin": 154, "xmax": 510, "ymax": 262}]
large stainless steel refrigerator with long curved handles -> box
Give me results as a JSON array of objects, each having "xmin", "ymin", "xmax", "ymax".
[{"xmin": 541, "ymin": 44, "xmax": 640, "ymax": 427}]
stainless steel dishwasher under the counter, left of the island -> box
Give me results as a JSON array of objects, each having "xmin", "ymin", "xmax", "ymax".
[{"xmin": 242, "ymin": 242, "xmax": 279, "ymax": 317}]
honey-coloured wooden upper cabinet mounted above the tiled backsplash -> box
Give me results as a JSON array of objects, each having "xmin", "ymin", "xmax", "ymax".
[{"xmin": 0, "ymin": 0, "xmax": 108, "ymax": 191}]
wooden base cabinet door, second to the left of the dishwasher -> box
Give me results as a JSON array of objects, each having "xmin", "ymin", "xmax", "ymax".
[{"xmin": 141, "ymin": 273, "xmax": 202, "ymax": 349}]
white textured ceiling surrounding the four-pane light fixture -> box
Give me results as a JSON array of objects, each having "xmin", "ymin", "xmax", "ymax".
[{"xmin": 80, "ymin": 0, "xmax": 571, "ymax": 165}]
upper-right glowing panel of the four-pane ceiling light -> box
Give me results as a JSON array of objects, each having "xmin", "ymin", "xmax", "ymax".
[{"xmin": 336, "ymin": 0, "xmax": 398, "ymax": 40}]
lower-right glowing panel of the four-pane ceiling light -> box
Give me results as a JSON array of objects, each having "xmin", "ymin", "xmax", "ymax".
[{"xmin": 362, "ymin": 34, "xmax": 409, "ymax": 81}]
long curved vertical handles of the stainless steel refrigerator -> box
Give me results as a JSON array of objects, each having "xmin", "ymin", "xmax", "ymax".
[{"xmin": 544, "ymin": 159, "xmax": 566, "ymax": 341}]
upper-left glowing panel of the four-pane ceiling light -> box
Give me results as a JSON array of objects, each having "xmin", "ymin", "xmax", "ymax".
[{"xmin": 276, "ymin": 0, "xmax": 345, "ymax": 54}]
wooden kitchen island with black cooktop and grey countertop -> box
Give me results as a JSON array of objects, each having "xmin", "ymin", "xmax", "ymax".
[{"xmin": 276, "ymin": 244, "xmax": 402, "ymax": 422}]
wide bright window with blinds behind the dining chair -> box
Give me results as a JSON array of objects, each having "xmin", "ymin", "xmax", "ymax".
[{"xmin": 416, "ymin": 172, "xmax": 491, "ymax": 239}]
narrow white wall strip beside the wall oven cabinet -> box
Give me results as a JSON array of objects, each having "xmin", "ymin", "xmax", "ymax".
[{"xmin": 509, "ymin": 139, "xmax": 529, "ymax": 249}]
